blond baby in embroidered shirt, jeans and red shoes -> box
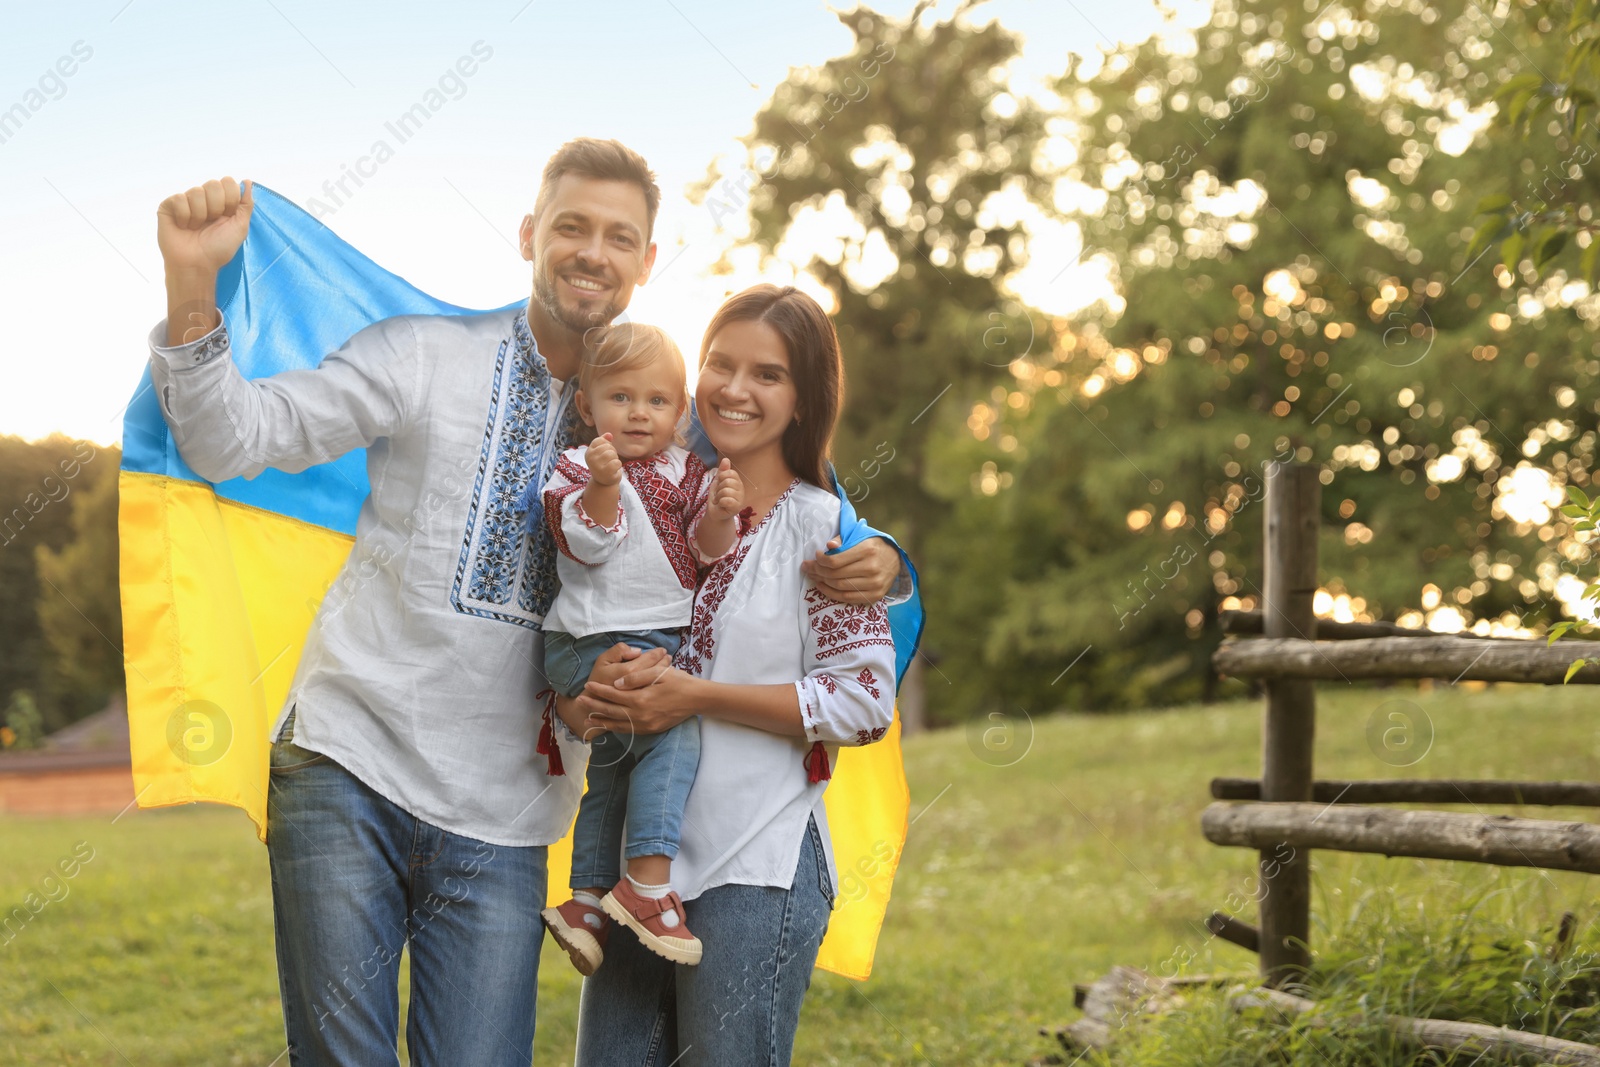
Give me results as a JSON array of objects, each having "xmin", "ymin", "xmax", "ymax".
[{"xmin": 539, "ymin": 323, "xmax": 744, "ymax": 976}]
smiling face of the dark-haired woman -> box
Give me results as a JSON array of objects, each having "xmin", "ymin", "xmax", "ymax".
[{"xmin": 694, "ymin": 322, "xmax": 800, "ymax": 459}]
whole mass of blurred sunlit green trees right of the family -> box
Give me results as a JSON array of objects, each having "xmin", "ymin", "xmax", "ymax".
[{"xmin": 720, "ymin": 0, "xmax": 1600, "ymax": 720}]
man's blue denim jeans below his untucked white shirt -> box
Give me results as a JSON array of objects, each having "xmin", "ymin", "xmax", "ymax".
[{"xmin": 267, "ymin": 718, "xmax": 546, "ymax": 1067}]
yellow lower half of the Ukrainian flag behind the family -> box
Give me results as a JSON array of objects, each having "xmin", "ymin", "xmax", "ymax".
[{"xmin": 118, "ymin": 470, "xmax": 910, "ymax": 979}]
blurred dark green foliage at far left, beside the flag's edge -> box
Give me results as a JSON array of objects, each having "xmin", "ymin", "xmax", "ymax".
[{"xmin": 0, "ymin": 435, "xmax": 122, "ymax": 744}]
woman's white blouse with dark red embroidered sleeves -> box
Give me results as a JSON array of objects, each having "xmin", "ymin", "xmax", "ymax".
[{"xmin": 672, "ymin": 482, "xmax": 894, "ymax": 899}]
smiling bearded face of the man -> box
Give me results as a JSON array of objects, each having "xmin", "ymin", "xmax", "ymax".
[{"xmin": 522, "ymin": 174, "xmax": 656, "ymax": 333}]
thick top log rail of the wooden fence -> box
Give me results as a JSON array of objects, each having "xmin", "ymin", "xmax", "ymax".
[{"xmin": 1211, "ymin": 637, "xmax": 1600, "ymax": 685}]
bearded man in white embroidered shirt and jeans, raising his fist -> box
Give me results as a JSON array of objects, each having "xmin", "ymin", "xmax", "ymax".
[{"xmin": 150, "ymin": 139, "xmax": 901, "ymax": 1067}]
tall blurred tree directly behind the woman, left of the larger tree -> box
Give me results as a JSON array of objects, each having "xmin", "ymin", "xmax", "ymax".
[{"xmin": 702, "ymin": 3, "xmax": 1046, "ymax": 726}]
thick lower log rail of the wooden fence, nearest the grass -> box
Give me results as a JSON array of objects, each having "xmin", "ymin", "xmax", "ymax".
[{"xmin": 1200, "ymin": 801, "xmax": 1600, "ymax": 873}]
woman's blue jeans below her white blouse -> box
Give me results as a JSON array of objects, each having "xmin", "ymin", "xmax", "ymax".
[{"xmin": 576, "ymin": 812, "xmax": 834, "ymax": 1067}]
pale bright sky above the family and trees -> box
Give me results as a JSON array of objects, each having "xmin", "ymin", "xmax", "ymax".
[{"xmin": 0, "ymin": 0, "xmax": 1162, "ymax": 443}]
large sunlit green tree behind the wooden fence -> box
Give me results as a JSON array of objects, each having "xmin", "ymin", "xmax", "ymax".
[{"xmin": 966, "ymin": 0, "xmax": 1600, "ymax": 707}]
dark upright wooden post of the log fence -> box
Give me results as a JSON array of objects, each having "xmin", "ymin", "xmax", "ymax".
[{"xmin": 1259, "ymin": 462, "xmax": 1322, "ymax": 985}]
